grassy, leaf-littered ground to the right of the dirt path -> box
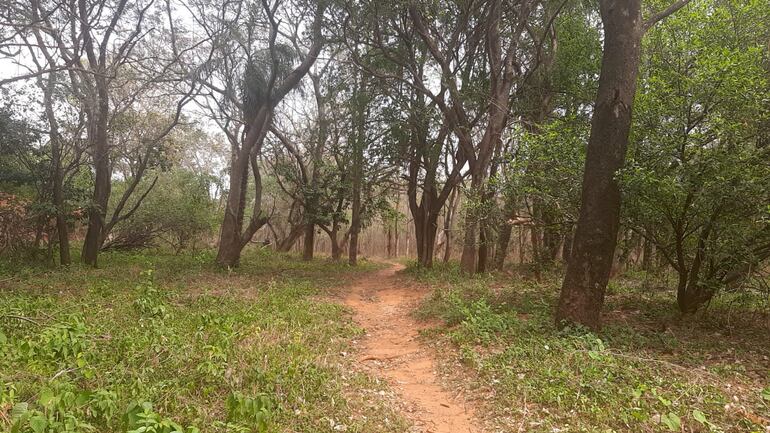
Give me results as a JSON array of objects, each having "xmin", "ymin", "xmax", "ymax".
[{"xmin": 408, "ymin": 265, "xmax": 770, "ymax": 432}]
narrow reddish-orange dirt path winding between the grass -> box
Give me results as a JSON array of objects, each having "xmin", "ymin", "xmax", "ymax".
[{"xmin": 344, "ymin": 265, "xmax": 482, "ymax": 433}]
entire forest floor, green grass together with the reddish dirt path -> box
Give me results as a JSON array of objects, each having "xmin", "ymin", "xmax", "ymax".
[{"xmin": 0, "ymin": 249, "xmax": 770, "ymax": 433}]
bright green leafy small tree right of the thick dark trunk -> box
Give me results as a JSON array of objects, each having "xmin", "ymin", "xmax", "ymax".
[{"xmin": 621, "ymin": 0, "xmax": 770, "ymax": 303}]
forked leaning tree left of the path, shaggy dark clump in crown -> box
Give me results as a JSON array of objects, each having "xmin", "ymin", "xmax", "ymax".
[{"xmin": 194, "ymin": 0, "xmax": 326, "ymax": 267}]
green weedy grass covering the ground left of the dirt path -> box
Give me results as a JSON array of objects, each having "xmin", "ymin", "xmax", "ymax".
[{"xmin": 0, "ymin": 248, "xmax": 399, "ymax": 433}]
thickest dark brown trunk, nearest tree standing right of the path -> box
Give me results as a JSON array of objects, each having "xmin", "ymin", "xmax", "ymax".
[{"xmin": 556, "ymin": 0, "xmax": 643, "ymax": 329}]
